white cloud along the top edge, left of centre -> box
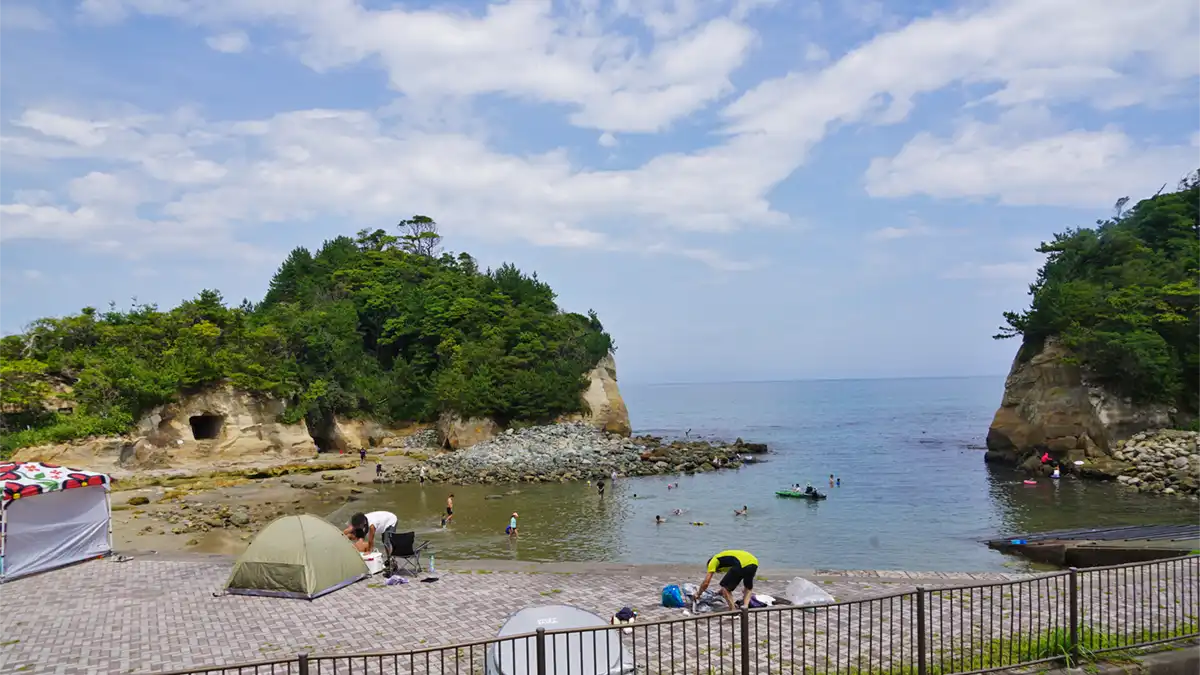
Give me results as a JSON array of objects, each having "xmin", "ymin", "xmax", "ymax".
[{"xmin": 80, "ymin": 0, "xmax": 755, "ymax": 132}]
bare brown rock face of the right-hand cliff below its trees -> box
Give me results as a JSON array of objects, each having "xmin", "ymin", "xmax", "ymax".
[{"xmin": 986, "ymin": 340, "xmax": 1174, "ymax": 468}]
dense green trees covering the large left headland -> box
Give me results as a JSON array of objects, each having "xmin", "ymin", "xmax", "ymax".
[{"xmin": 0, "ymin": 216, "xmax": 613, "ymax": 454}]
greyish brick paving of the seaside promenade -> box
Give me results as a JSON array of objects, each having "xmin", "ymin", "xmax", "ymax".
[{"xmin": 0, "ymin": 558, "xmax": 1200, "ymax": 675}]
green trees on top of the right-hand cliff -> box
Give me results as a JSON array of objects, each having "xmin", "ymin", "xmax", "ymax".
[{"xmin": 996, "ymin": 172, "xmax": 1200, "ymax": 412}]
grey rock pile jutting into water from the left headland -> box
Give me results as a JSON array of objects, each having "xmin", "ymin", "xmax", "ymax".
[{"xmin": 377, "ymin": 423, "xmax": 767, "ymax": 485}]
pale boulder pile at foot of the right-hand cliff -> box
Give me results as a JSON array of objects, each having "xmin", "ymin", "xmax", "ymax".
[{"xmin": 1112, "ymin": 430, "xmax": 1200, "ymax": 498}]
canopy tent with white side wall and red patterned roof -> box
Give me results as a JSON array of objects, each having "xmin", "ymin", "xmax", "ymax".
[{"xmin": 0, "ymin": 462, "xmax": 113, "ymax": 583}]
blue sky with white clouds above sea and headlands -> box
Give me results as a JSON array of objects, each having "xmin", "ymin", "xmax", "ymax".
[{"xmin": 0, "ymin": 0, "xmax": 1200, "ymax": 382}]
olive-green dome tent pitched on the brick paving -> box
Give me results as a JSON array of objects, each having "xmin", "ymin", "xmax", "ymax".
[{"xmin": 226, "ymin": 514, "xmax": 367, "ymax": 601}]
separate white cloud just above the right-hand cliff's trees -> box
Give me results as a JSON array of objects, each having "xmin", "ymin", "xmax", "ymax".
[{"xmin": 866, "ymin": 115, "xmax": 1198, "ymax": 208}]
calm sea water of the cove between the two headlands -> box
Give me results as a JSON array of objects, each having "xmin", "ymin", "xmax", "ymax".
[{"xmin": 331, "ymin": 377, "xmax": 1200, "ymax": 571}]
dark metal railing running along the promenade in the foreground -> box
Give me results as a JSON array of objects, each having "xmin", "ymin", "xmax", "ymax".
[{"xmin": 159, "ymin": 555, "xmax": 1200, "ymax": 675}]
